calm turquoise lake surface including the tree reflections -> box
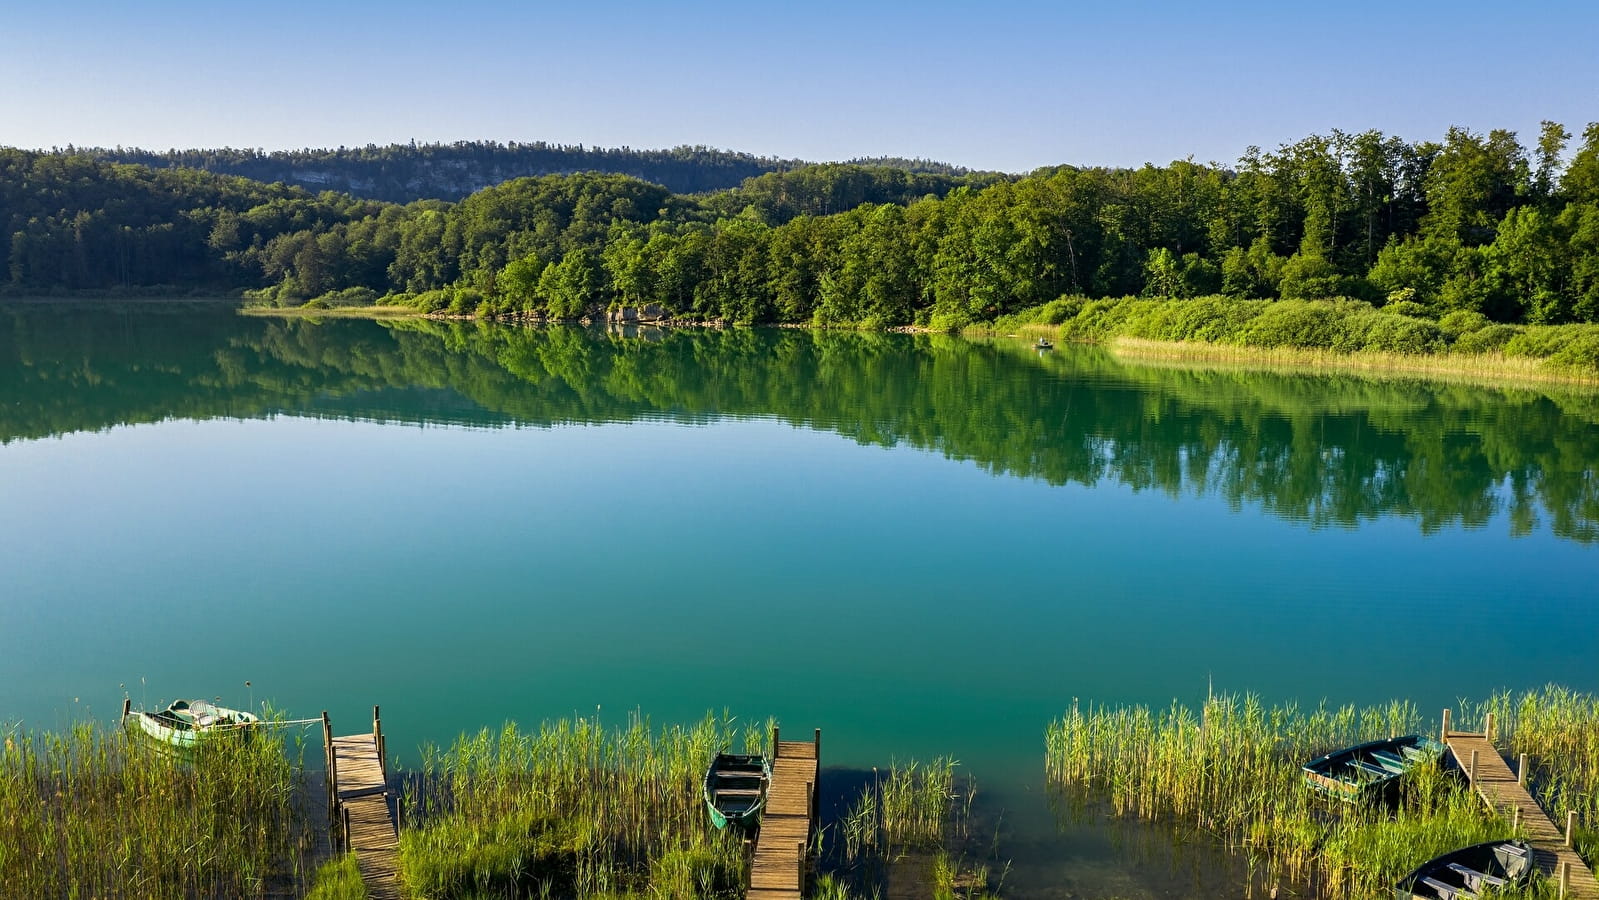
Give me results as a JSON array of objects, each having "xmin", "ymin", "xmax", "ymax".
[{"xmin": 0, "ymin": 304, "xmax": 1599, "ymax": 895}]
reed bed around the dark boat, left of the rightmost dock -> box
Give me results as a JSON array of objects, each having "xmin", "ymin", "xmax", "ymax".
[{"xmin": 1046, "ymin": 695, "xmax": 1511, "ymax": 898}]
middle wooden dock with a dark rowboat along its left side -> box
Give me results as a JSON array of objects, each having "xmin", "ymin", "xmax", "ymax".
[{"xmin": 745, "ymin": 727, "xmax": 822, "ymax": 900}]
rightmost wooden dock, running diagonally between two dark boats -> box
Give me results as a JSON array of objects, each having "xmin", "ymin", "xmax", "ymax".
[{"xmin": 1444, "ymin": 710, "xmax": 1599, "ymax": 900}]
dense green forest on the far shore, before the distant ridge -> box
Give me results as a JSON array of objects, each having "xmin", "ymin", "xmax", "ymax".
[{"xmin": 9, "ymin": 123, "xmax": 1599, "ymax": 342}]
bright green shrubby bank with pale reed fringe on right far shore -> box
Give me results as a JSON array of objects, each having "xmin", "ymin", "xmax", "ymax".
[{"xmin": 979, "ymin": 296, "xmax": 1599, "ymax": 382}]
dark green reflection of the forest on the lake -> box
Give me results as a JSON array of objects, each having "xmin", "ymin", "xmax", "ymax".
[{"xmin": 0, "ymin": 304, "xmax": 1599, "ymax": 542}]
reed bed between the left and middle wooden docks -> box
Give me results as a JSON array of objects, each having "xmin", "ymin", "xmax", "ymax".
[{"xmin": 400, "ymin": 715, "xmax": 771, "ymax": 900}]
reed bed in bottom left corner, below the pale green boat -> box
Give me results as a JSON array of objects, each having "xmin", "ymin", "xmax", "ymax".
[{"xmin": 0, "ymin": 724, "xmax": 315, "ymax": 900}]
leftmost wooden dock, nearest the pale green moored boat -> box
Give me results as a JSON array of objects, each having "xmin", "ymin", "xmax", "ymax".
[{"xmin": 321, "ymin": 707, "xmax": 403, "ymax": 900}]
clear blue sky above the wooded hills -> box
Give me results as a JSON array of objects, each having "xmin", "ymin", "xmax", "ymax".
[{"xmin": 0, "ymin": 0, "xmax": 1599, "ymax": 171}]
